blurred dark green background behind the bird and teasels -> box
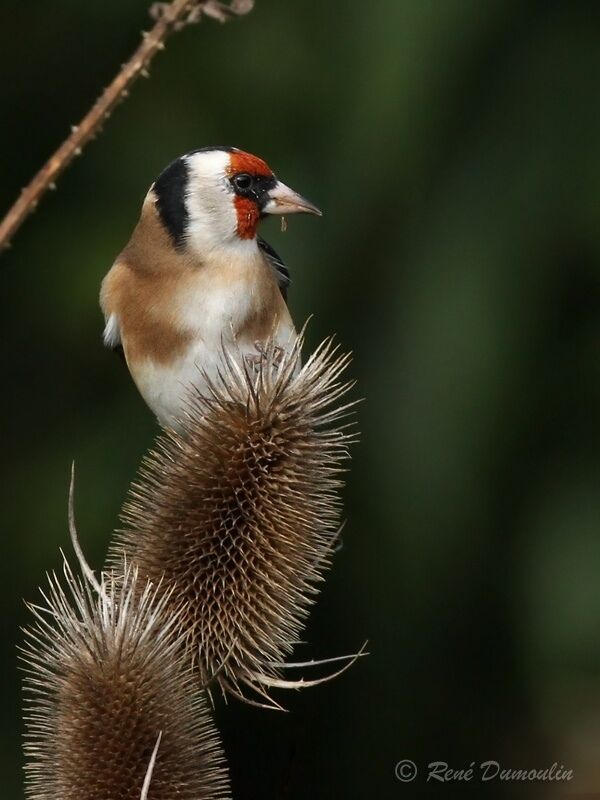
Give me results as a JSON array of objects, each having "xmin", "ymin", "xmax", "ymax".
[{"xmin": 0, "ymin": 0, "xmax": 600, "ymax": 800}]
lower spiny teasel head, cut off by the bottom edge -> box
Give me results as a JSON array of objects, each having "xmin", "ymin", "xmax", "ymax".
[{"xmin": 22, "ymin": 562, "xmax": 230, "ymax": 800}]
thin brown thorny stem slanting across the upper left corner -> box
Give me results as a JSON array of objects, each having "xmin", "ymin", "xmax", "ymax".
[{"xmin": 0, "ymin": 0, "xmax": 254, "ymax": 251}]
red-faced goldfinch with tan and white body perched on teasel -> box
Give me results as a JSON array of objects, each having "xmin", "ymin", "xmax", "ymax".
[{"xmin": 100, "ymin": 146, "xmax": 322, "ymax": 431}]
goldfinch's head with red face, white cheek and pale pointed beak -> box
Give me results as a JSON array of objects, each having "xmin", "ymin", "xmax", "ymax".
[{"xmin": 150, "ymin": 147, "xmax": 321, "ymax": 255}]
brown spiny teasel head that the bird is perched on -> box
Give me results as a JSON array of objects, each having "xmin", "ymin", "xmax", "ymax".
[{"xmin": 109, "ymin": 340, "xmax": 354, "ymax": 706}]
